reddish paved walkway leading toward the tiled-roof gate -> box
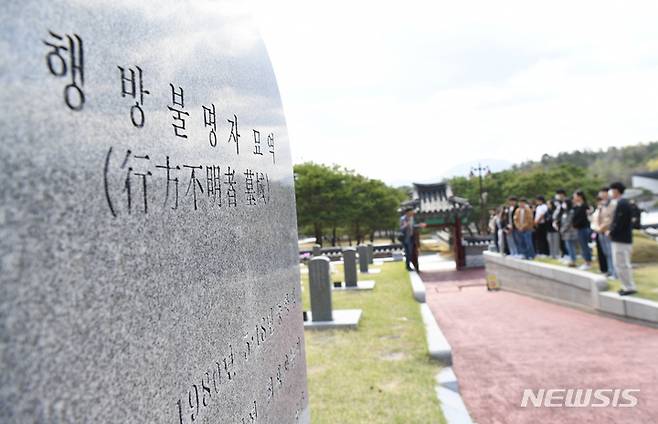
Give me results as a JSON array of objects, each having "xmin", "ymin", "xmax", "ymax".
[{"xmin": 421, "ymin": 255, "xmax": 658, "ymax": 424}]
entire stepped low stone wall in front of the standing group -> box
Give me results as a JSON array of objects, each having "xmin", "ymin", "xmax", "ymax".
[{"xmin": 484, "ymin": 252, "xmax": 658, "ymax": 325}]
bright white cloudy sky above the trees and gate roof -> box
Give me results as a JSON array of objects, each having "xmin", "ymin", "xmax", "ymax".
[{"xmin": 253, "ymin": 0, "xmax": 658, "ymax": 185}]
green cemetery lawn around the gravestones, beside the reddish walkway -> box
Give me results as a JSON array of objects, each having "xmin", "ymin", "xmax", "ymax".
[{"xmin": 302, "ymin": 262, "xmax": 445, "ymax": 424}]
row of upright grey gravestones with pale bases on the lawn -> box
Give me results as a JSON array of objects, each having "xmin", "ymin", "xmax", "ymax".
[{"xmin": 304, "ymin": 245, "xmax": 378, "ymax": 329}]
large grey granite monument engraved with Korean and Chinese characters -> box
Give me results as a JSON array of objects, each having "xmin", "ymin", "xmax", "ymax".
[{"xmin": 0, "ymin": 0, "xmax": 310, "ymax": 424}]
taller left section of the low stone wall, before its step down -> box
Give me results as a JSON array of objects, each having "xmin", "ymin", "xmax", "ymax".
[{"xmin": 483, "ymin": 252, "xmax": 608, "ymax": 309}]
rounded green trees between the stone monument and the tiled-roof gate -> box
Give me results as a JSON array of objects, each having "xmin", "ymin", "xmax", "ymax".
[{"xmin": 294, "ymin": 162, "xmax": 406, "ymax": 243}]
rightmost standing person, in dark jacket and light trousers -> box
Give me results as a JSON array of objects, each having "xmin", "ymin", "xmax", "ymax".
[{"xmin": 609, "ymin": 182, "xmax": 637, "ymax": 296}]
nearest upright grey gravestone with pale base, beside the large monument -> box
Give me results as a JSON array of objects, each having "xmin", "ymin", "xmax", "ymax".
[{"xmin": 304, "ymin": 256, "xmax": 361, "ymax": 330}]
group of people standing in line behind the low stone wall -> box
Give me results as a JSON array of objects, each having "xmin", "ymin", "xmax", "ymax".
[{"xmin": 489, "ymin": 182, "xmax": 636, "ymax": 295}]
